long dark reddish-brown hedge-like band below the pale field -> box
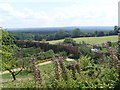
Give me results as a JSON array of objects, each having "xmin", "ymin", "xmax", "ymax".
[{"xmin": 16, "ymin": 41, "xmax": 78, "ymax": 57}]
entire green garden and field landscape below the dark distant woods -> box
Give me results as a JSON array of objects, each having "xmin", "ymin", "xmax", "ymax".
[{"xmin": 0, "ymin": 27, "xmax": 120, "ymax": 89}]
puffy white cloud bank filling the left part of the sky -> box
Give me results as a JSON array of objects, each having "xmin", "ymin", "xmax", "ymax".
[{"xmin": 0, "ymin": 4, "xmax": 51, "ymax": 27}]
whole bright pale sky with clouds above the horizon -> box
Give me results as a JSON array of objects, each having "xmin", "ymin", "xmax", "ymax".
[{"xmin": 0, "ymin": 0, "xmax": 119, "ymax": 28}]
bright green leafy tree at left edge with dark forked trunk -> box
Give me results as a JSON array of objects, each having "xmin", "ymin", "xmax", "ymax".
[{"xmin": 0, "ymin": 28, "xmax": 22, "ymax": 80}]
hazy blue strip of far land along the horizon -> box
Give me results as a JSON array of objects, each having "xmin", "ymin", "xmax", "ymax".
[{"xmin": 6, "ymin": 26, "xmax": 114, "ymax": 32}]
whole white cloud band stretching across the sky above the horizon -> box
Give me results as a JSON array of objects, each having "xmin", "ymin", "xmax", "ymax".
[{"xmin": 0, "ymin": 3, "xmax": 117, "ymax": 28}]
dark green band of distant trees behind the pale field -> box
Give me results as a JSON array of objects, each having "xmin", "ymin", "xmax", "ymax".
[{"xmin": 9, "ymin": 26, "xmax": 118, "ymax": 41}]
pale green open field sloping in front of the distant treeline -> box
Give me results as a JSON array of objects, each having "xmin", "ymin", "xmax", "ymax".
[{"xmin": 49, "ymin": 35, "xmax": 118, "ymax": 44}]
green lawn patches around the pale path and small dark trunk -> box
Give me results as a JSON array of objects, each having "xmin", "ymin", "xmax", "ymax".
[{"xmin": 0, "ymin": 61, "xmax": 75, "ymax": 88}]
